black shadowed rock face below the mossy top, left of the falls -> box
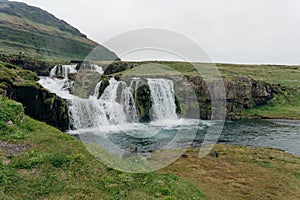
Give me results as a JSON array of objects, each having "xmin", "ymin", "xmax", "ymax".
[{"xmin": 7, "ymin": 85, "xmax": 69, "ymax": 131}]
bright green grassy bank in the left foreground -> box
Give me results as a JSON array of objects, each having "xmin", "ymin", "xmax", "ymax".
[{"xmin": 0, "ymin": 98, "xmax": 205, "ymax": 199}]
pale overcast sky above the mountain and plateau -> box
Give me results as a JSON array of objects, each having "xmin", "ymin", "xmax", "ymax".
[{"xmin": 12, "ymin": 0, "xmax": 300, "ymax": 64}]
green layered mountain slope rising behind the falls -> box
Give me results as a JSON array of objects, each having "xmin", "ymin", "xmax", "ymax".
[{"xmin": 0, "ymin": 0, "xmax": 117, "ymax": 61}]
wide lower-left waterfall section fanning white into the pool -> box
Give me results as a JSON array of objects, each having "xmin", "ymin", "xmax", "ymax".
[{"xmin": 69, "ymin": 78, "xmax": 138, "ymax": 129}]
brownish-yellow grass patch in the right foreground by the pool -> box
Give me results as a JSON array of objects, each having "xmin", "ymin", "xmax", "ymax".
[{"xmin": 160, "ymin": 144, "xmax": 300, "ymax": 200}]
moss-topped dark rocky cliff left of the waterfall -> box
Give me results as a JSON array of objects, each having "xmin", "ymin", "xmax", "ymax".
[{"xmin": 0, "ymin": 62, "xmax": 69, "ymax": 131}]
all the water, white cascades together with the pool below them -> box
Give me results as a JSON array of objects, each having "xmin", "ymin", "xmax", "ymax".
[{"xmin": 39, "ymin": 65, "xmax": 300, "ymax": 156}]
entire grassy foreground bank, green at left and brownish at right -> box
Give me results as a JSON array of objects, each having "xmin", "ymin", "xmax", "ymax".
[{"xmin": 0, "ymin": 98, "xmax": 300, "ymax": 199}]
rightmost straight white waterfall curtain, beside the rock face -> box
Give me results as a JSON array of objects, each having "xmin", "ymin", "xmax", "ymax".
[{"xmin": 148, "ymin": 79, "xmax": 178, "ymax": 120}]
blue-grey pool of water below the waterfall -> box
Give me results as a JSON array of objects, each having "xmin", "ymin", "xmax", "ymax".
[{"xmin": 71, "ymin": 120, "xmax": 300, "ymax": 156}]
